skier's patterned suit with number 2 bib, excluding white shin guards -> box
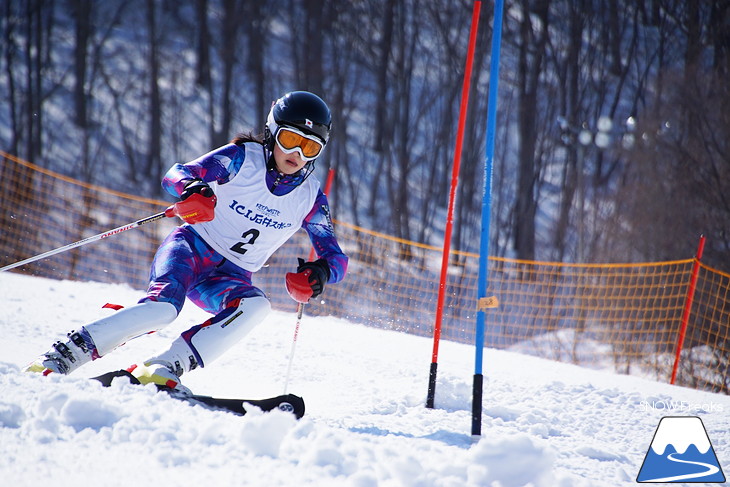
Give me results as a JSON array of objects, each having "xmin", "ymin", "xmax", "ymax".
[{"xmin": 145, "ymin": 142, "xmax": 348, "ymax": 314}]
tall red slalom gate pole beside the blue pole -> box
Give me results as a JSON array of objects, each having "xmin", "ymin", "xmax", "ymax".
[{"xmin": 426, "ymin": 0, "xmax": 482, "ymax": 409}]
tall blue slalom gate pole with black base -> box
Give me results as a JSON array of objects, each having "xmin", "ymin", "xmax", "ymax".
[{"xmin": 471, "ymin": 0, "xmax": 504, "ymax": 436}]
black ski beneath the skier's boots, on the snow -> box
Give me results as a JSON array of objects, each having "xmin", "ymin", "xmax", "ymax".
[{"xmin": 92, "ymin": 370, "xmax": 304, "ymax": 419}]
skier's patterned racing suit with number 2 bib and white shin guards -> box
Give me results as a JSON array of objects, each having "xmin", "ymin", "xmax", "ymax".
[{"xmin": 69, "ymin": 142, "xmax": 348, "ymax": 381}]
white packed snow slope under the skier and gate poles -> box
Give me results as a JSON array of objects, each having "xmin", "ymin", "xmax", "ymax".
[{"xmin": 0, "ymin": 273, "xmax": 730, "ymax": 487}]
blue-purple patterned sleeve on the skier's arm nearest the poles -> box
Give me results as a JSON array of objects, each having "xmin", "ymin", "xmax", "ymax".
[{"xmin": 302, "ymin": 191, "xmax": 348, "ymax": 283}]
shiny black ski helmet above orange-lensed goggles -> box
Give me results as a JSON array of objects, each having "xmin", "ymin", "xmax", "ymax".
[{"xmin": 264, "ymin": 91, "xmax": 332, "ymax": 149}]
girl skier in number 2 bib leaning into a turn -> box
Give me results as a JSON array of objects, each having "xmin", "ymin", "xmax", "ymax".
[{"xmin": 26, "ymin": 91, "xmax": 348, "ymax": 390}]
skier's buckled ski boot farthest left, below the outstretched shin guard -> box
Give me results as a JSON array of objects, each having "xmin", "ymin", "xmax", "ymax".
[{"xmin": 23, "ymin": 328, "xmax": 100, "ymax": 375}]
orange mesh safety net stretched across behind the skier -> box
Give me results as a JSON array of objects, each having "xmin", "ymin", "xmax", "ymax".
[{"xmin": 0, "ymin": 152, "xmax": 730, "ymax": 394}]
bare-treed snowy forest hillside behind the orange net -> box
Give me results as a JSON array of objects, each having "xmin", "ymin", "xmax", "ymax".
[{"xmin": 0, "ymin": 0, "xmax": 730, "ymax": 268}]
